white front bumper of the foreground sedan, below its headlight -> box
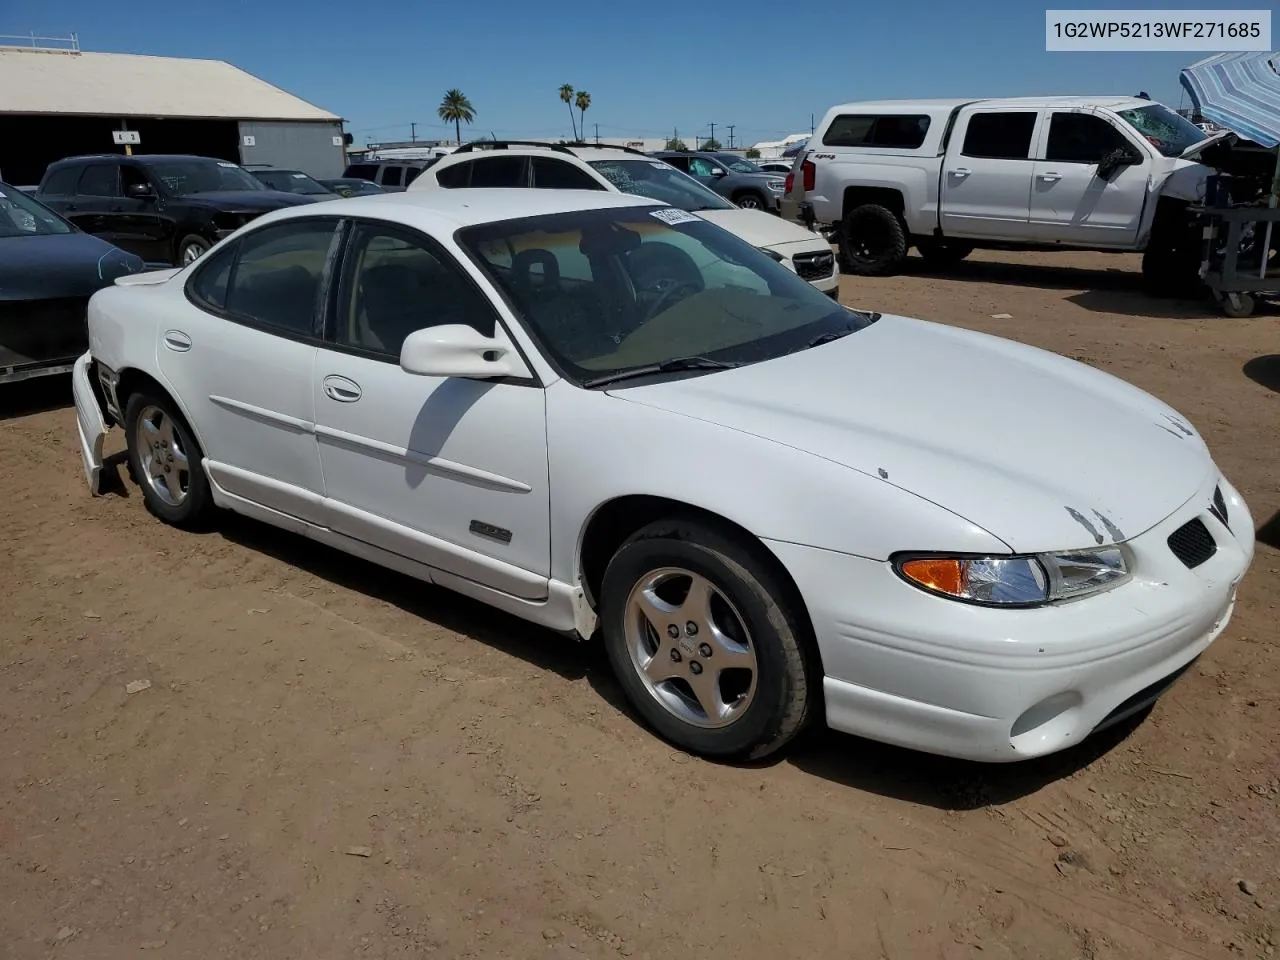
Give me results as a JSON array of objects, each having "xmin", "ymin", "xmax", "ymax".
[{"xmin": 769, "ymin": 471, "xmax": 1253, "ymax": 762}]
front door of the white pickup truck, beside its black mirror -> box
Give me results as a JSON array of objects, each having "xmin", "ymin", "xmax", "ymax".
[{"xmin": 1030, "ymin": 108, "xmax": 1151, "ymax": 247}]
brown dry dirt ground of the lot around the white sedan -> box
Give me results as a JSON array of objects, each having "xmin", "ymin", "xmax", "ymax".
[{"xmin": 0, "ymin": 253, "xmax": 1280, "ymax": 960}]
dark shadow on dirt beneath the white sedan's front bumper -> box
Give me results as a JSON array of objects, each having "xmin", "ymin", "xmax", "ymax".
[{"xmin": 785, "ymin": 707, "xmax": 1151, "ymax": 810}]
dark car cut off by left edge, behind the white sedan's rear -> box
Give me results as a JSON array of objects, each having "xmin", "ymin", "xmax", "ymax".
[{"xmin": 0, "ymin": 183, "xmax": 143, "ymax": 383}]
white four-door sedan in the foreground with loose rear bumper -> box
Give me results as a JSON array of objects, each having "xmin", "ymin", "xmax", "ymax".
[{"xmin": 74, "ymin": 189, "xmax": 1253, "ymax": 760}]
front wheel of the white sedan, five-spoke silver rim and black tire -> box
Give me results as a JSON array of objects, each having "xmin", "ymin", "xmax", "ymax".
[{"xmin": 600, "ymin": 520, "xmax": 820, "ymax": 760}]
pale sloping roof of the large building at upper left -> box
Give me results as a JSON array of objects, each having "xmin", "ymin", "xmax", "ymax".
[{"xmin": 0, "ymin": 47, "xmax": 342, "ymax": 122}]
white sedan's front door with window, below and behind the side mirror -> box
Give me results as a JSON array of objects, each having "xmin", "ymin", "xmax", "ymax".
[{"xmin": 314, "ymin": 221, "xmax": 550, "ymax": 600}]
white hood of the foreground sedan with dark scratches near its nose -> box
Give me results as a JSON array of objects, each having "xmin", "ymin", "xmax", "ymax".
[{"xmin": 612, "ymin": 316, "xmax": 1215, "ymax": 553}]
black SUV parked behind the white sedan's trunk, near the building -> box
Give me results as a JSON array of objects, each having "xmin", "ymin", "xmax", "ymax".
[{"xmin": 36, "ymin": 154, "xmax": 316, "ymax": 265}]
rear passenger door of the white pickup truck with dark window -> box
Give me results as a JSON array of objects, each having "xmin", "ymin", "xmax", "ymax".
[{"xmin": 940, "ymin": 109, "xmax": 1042, "ymax": 239}]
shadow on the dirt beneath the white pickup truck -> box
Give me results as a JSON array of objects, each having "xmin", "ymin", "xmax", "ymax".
[{"xmin": 904, "ymin": 257, "xmax": 1220, "ymax": 320}]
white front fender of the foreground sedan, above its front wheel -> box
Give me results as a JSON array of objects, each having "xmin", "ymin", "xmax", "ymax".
[{"xmin": 547, "ymin": 381, "xmax": 1009, "ymax": 582}]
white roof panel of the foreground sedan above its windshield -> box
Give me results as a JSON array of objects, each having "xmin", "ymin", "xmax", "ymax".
[{"xmin": 276, "ymin": 187, "xmax": 667, "ymax": 230}]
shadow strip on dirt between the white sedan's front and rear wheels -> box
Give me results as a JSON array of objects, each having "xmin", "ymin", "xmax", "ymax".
[{"xmin": 210, "ymin": 512, "xmax": 607, "ymax": 680}]
